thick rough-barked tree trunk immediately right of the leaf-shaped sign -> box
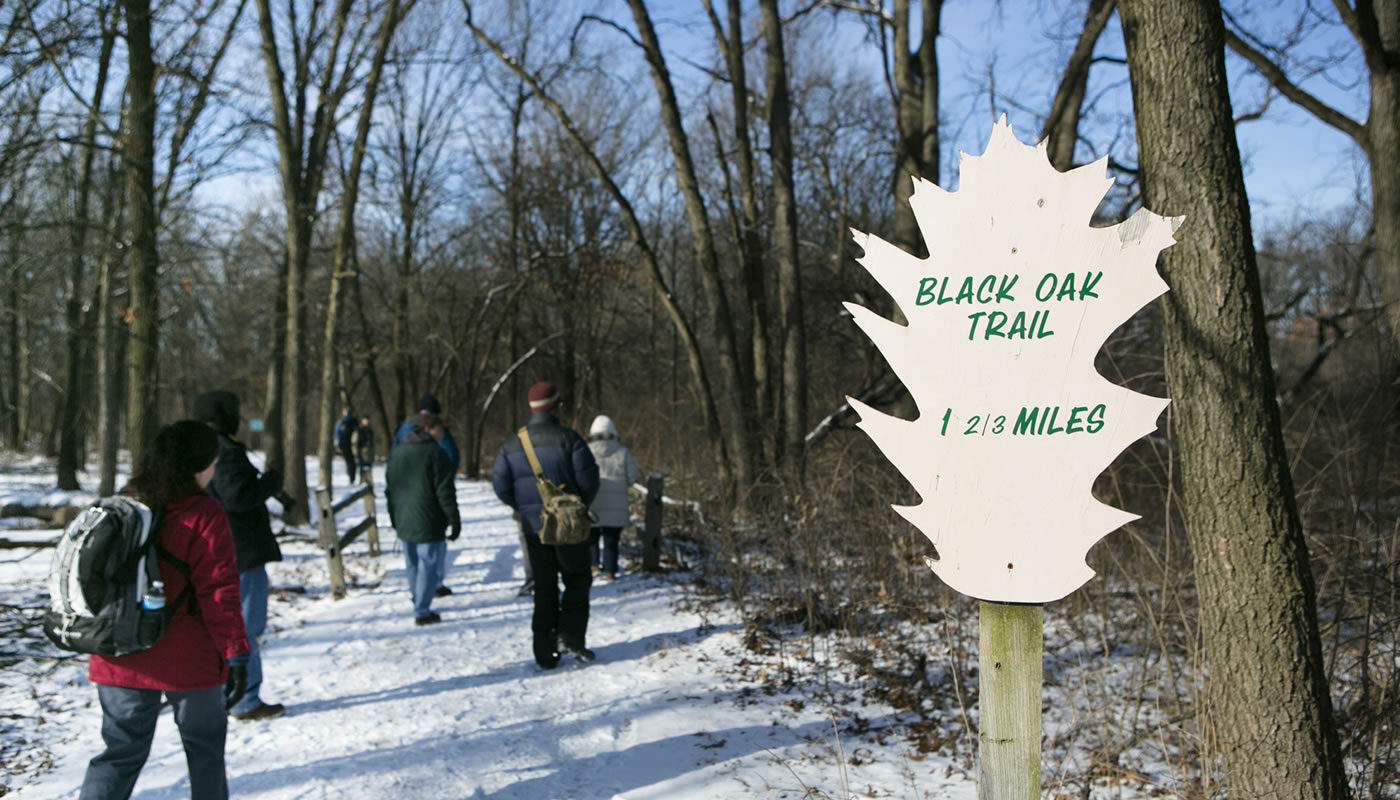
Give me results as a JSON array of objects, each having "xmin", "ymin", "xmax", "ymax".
[{"xmin": 1119, "ymin": 0, "xmax": 1347, "ymax": 800}]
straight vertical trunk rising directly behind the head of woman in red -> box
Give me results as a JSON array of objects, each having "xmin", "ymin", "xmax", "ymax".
[{"xmin": 123, "ymin": 0, "xmax": 160, "ymax": 464}]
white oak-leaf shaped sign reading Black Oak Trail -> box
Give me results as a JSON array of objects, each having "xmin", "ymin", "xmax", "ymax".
[{"xmin": 846, "ymin": 116, "xmax": 1183, "ymax": 602}]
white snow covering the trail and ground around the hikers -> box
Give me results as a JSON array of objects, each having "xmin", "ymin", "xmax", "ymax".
[{"xmin": 0, "ymin": 460, "xmax": 976, "ymax": 800}]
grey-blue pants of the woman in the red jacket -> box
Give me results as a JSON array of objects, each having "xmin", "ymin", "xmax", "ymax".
[{"xmin": 80, "ymin": 685, "xmax": 228, "ymax": 800}]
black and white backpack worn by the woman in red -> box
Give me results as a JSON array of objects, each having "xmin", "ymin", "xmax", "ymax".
[{"xmin": 43, "ymin": 496, "xmax": 193, "ymax": 657}]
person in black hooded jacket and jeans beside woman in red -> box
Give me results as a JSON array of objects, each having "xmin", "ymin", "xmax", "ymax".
[{"xmin": 195, "ymin": 391, "xmax": 286, "ymax": 720}]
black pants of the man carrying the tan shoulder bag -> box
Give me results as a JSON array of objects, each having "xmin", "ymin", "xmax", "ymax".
[{"xmin": 525, "ymin": 537, "xmax": 594, "ymax": 667}]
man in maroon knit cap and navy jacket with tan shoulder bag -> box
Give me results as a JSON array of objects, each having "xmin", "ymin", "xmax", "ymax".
[{"xmin": 491, "ymin": 381, "xmax": 598, "ymax": 670}]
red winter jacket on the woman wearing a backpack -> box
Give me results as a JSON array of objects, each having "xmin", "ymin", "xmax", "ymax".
[{"xmin": 88, "ymin": 495, "xmax": 249, "ymax": 692}]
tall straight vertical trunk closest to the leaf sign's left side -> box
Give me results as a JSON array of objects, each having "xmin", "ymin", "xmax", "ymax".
[{"xmin": 759, "ymin": 0, "xmax": 806, "ymax": 475}]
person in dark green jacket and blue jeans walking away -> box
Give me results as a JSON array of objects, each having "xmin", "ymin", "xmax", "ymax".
[{"xmin": 384, "ymin": 413, "xmax": 462, "ymax": 625}]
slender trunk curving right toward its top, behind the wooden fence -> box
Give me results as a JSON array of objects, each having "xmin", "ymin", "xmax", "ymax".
[{"xmin": 316, "ymin": 0, "xmax": 416, "ymax": 490}]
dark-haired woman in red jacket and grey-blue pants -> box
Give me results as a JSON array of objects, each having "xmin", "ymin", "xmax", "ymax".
[{"xmin": 81, "ymin": 420, "xmax": 249, "ymax": 800}]
